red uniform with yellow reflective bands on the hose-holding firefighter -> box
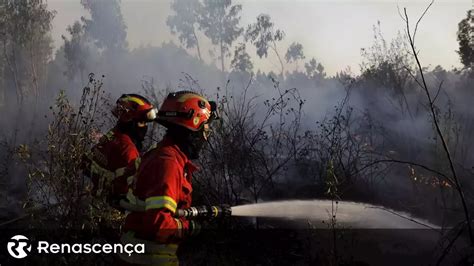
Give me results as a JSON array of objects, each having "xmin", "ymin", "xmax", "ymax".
[{"xmin": 123, "ymin": 137, "xmax": 197, "ymax": 264}]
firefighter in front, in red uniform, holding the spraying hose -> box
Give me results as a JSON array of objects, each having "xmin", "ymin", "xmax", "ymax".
[{"xmin": 121, "ymin": 91, "xmax": 217, "ymax": 265}]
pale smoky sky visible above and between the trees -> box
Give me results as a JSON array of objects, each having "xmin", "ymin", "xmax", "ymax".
[{"xmin": 48, "ymin": 0, "xmax": 472, "ymax": 75}]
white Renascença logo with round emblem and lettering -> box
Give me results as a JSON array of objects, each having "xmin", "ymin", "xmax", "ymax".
[{"xmin": 7, "ymin": 235, "xmax": 145, "ymax": 259}]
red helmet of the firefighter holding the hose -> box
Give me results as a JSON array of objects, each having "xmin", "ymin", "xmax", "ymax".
[{"xmin": 156, "ymin": 91, "xmax": 218, "ymax": 131}]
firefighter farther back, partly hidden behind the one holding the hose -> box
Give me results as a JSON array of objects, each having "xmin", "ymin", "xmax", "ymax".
[{"xmin": 84, "ymin": 94, "xmax": 157, "ymax": 209}]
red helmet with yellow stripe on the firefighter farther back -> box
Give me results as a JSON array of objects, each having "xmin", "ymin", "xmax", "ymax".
[{"xmin": 112, "ymin": 94, "xmax": 157, "ymax": 122}]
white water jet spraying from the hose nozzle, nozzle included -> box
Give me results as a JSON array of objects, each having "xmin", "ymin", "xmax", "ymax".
[{"xmin": 176, "ymin": 200, "xmax": 439, "ymax": 229}]
